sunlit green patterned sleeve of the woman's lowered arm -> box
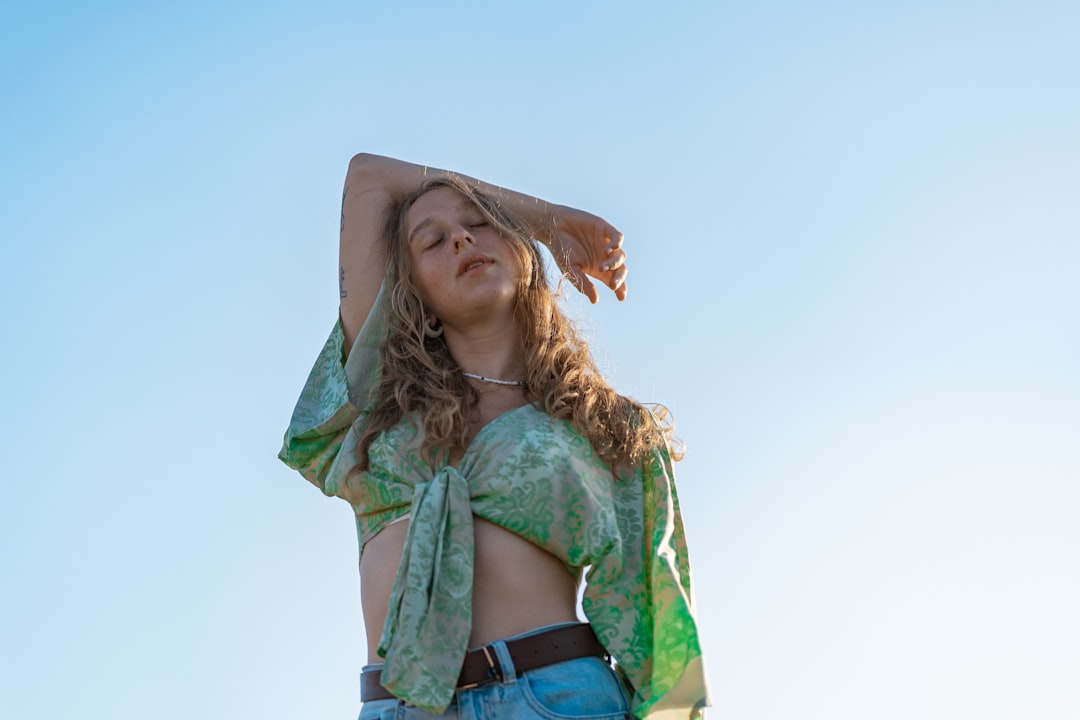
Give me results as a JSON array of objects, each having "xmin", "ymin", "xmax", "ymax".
[{"xmin": 582, "ymin": 448, "xmax": 708, "ymax": 720}]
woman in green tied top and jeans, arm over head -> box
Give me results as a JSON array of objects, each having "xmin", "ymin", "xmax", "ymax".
[{"xmin": 280, "ymin": 154, "xmax": 706, "ymax": 720}]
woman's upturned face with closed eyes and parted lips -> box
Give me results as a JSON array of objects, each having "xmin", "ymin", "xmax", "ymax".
[{"xmin": 405, "ymin": 188, "xmax": 521, "ymax": 330}]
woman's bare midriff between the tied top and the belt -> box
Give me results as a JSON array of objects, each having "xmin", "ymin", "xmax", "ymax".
[{"xmin": 360, "ymin": 516, "xmax": 578, "ymax": 663}]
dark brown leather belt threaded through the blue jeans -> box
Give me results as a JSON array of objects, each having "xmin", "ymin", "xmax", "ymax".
[{"xmin": 360, "ymin": 623, "xmax": 607, "ymax": 703}]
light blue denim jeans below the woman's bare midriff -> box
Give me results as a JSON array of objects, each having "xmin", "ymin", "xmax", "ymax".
[{"xmin": 360, "ymin": 626, "xmax": 632, "ymax": 720}]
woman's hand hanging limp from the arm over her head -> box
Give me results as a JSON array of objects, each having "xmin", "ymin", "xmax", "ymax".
[{"xmin": 548, "ymin": 205, "xmax": 626, "ymax": 302}]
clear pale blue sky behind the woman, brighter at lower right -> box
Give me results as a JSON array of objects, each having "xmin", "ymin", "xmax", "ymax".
[{"xmin": 0, "ymin": 1, "xmax": 1080, "ymax": 720}]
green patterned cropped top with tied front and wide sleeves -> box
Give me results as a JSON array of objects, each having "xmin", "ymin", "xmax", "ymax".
[{"xmin": 279, "ymin": 280, "xmax": 707, "ymax": 719}]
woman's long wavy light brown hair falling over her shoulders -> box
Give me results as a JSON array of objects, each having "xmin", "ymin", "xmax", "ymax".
[{"xmin": 357, "ymin": 176, "xmax": 678, "ymax": 475}]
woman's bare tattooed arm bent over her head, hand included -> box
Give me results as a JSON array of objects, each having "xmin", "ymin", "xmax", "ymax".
[{"xmin": 338, "ymin": 153, "xmax": 626, "ymax": 352}]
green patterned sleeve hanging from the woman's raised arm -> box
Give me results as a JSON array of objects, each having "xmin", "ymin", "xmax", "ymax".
[{"xmin": 278, "ymin": 281, "xmax": 390, "ymax": 500}]
